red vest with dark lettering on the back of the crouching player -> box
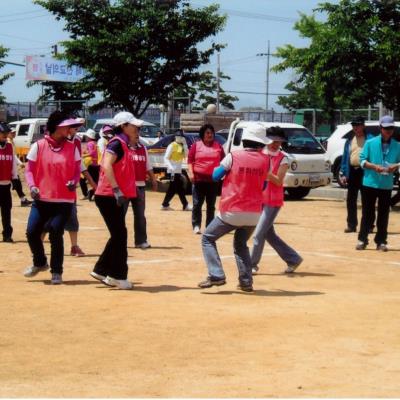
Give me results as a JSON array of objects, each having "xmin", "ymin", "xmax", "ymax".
[{"xmin": 219, "ymin": 150, "xmax": 268, "ymax": 213}]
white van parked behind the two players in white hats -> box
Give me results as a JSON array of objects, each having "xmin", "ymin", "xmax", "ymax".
[{"xmin": 224, "ymin": 119, "xmax": 332, "ymax": 199}]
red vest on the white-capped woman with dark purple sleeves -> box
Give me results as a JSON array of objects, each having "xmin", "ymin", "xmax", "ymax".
[{"xmin": 96, "ymin": 136, "xmax": 136, "ymax": 199}]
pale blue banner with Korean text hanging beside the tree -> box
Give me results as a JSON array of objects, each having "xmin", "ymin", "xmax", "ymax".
[{"xmin": 25, "ymin": 56, "xmax": 85, "ymax": 82}]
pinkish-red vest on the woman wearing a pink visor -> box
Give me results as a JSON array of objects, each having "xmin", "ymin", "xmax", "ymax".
[{"xmin": 34, "ymin": 139, "xmax": 76, "ymax": 201}]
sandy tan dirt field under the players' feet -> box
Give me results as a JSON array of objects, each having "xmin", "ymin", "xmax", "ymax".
[{"xmin": 0, "ymin": 193, "xmax": 400, "ymax": 397}]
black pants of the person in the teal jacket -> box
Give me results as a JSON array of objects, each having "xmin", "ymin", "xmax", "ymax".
[{"xmin": 358, "ymin": 186, "xmax": 392, "ymax": 245}]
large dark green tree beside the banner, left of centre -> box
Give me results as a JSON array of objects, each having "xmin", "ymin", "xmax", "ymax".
[{"xmin": 35, "ymin": 0, "xmax": 226, "ymax": 116}]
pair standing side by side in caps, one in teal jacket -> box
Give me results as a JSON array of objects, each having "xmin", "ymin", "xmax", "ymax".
[{"xmin": 340, "ymin": 115, "xmax": 400, "ymax": 251}]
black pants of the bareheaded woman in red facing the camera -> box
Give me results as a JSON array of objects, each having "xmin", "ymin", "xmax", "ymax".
[{"xmin": 192, "ymin": 182, "xmax": 219, "ymax": 228}]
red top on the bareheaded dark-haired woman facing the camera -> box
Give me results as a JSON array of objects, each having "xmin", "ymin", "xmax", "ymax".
[{"xmin": 193, "ymin": 140, "xmax": 223, "ymax": 181}]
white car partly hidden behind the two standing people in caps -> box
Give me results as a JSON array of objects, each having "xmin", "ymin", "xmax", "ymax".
[{"xmin": 324, "ymin": 121, "xmax": 400, "ymax": 183}]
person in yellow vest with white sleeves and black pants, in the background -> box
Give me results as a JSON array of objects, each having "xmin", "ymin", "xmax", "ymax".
[{"xmin": 161, "ymin": 129, "xmax": 192, "ymax": 211}]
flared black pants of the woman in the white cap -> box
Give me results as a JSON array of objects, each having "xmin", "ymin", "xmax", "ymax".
[{"xmin": 94, "ymin": 195, "xmax": 128, "ymax": 280}]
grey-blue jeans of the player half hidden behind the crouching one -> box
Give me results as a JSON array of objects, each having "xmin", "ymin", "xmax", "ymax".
[{"xmin": 251, "ymin": 205, "xmax": 302, "ymax": 267}]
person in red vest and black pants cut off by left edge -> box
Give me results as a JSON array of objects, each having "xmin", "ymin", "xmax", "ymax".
[{"xmin": 0, "ymin": 122, "xmax": 18, "ymax": 243}]
